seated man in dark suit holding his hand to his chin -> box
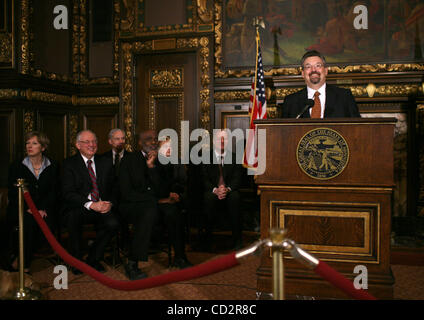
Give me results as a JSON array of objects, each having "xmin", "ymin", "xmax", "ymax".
[{"xmin": 119, "ymin": 130, "xmax": 192, "ymax": 280}]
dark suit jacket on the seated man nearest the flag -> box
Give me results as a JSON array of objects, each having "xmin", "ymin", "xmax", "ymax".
[{"xmin": 202, "ymin": 151, "xmax": 243, "ymax": 192}]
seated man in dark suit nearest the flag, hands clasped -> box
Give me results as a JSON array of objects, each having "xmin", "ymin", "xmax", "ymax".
[{"xmin": 202, "ymin": 130, "xmax": 243, "ymax": 249}]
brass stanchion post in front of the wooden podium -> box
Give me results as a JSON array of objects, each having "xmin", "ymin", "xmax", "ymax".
[{"xmin": 270, "ymin": 228, "xmax": 287, "ymax": 300}]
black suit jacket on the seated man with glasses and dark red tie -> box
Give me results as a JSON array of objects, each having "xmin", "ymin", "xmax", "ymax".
[{"xmin": 62, "ymin": 152, "xmax": 117, "ymax": 209}]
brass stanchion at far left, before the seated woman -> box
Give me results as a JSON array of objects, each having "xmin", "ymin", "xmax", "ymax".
[{"xmin": 14, "ymin": 179, "xmax": 42, "ymax": 300}]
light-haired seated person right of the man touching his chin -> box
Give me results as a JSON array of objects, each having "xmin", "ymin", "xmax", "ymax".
[{"xmin": 158, "ymin": 139, "xmax": 191, "ymax": 269}]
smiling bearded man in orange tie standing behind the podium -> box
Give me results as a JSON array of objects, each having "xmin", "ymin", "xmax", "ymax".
[{"xmin": 282, "ymin": 50, "xmax": 361, "ymax": 119}]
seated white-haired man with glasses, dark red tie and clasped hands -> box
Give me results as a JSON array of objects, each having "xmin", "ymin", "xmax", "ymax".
[{"xmin": 62, "ymin": 130, "xmax": 119, "ymax": 273}]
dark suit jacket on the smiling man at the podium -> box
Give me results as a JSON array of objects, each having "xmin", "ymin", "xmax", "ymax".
[{"xmin": 282, "ymin": 84, "xmax": 361, "ymax": 118}]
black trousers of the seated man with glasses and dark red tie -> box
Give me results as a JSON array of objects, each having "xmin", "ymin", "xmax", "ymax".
[{"xmin": 66, "ymin": 208, "xmax": 119, "ymax": 262}]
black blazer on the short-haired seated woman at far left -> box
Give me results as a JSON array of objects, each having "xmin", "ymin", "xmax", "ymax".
[{"xmin": 7, "ymin": 159, "xmax": 59, "ymax": 220}]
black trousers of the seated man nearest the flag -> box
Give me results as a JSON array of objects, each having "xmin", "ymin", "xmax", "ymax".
[{"xmin": 202, "ymin": 191, "xmax": 242, "ymax": 245}]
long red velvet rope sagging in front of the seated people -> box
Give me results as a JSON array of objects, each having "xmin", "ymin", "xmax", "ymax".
[{"xmin": 24, "ymin": 191, "xmax": 239, "ymax": 291}]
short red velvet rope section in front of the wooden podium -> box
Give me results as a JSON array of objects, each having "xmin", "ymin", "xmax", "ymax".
[{"xmin": 314, "ymin": 261, "xmax": 377, "ymax": 300}]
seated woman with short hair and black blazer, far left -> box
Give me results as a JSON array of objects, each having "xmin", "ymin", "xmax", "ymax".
[{"xmin": 7, "ymin": 131, "xmax": 58, "ymax": 272}]
